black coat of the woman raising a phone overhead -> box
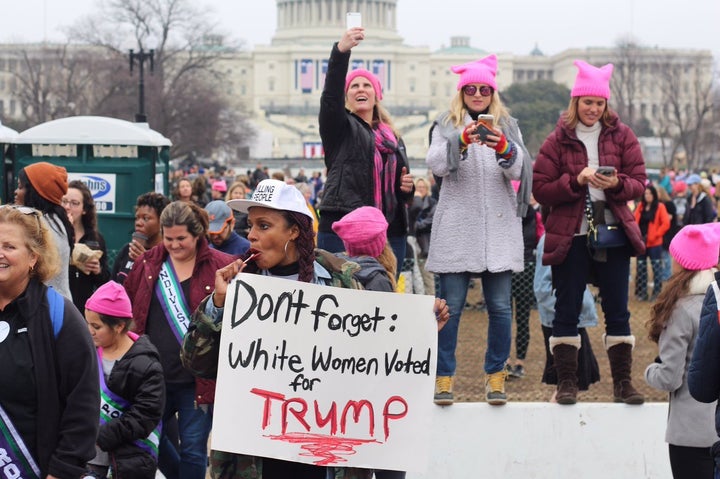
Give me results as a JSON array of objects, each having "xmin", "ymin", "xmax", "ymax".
[{"xmin": 318, "ymin": 43, "xmax": 413, "ymax": 237}]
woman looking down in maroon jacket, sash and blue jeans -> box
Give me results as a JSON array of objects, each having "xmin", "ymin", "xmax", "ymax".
[{"xmin": 124, "ymin": 201, "xmax": 233, "ymax": 479}]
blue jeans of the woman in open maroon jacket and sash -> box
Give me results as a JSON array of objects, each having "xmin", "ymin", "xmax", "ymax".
[{"xmin": 158, "ymin": 383, "xmax": 213, "ymax": 479}]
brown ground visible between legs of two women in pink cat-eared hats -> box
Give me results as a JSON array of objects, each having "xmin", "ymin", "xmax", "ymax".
[{"xmin": 453, "ymin": 278, "xmax": 667, "ymax": 402}]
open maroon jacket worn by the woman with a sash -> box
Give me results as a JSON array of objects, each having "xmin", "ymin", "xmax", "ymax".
[{"xmin": 123, "ymin": 237, "xmax": 234, "ymax": 404}]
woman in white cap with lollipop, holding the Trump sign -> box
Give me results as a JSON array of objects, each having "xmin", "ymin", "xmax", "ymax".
[{"xmin": 182, "ymin": 180, "xmax": 449, "ymax": 479}]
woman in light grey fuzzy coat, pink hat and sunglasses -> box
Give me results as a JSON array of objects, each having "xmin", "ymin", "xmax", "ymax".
[{"xmin": 426, "ymin": 55, "xmax": 530, "ymax": 405}]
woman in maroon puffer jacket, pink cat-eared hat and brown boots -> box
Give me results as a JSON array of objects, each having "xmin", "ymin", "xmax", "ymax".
[{"xmin": 533, "ymin": 60, "xmax": 646, "ymax": 404}]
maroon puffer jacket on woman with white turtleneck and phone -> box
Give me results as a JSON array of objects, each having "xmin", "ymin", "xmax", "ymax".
[{"xmin": 533, "ymin": 113, "xmax": 647, "ymax": 265}]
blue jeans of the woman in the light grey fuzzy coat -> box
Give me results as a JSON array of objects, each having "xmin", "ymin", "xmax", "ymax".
[{"xmin": 437, "ymin": 271, "xmax": 512, "ymax": 376}]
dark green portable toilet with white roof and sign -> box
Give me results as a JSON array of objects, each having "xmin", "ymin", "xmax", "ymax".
[{"xmin": 12, "ymin": 116, "xmax": 171, "ymax": 265}]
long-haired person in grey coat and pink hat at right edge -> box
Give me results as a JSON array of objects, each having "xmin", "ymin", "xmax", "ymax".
[{"xmin": 645, "ymin": 224, "xmax": 720, "ymax": 479}]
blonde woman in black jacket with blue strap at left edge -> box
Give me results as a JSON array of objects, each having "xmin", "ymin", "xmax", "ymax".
[{"xmin": 0, "ymin": 206, "xmax": 100, "ymax": 479}]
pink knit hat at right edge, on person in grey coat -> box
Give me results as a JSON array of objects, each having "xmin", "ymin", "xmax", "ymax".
[{"xmin": 670, "ymin": 223, "xmax": 720, "ymax": 271}]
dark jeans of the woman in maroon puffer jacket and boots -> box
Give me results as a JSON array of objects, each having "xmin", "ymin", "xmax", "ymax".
[{"xmin": 552, "ymin": 235, "xmax": 630, "ymax": 337}]
